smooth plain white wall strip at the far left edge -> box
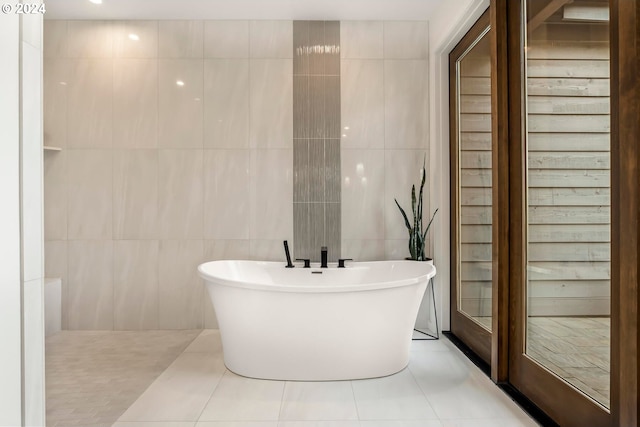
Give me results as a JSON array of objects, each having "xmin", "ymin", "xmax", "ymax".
[{"xmin": 0, "ymin": 14, "xmax": 22, "ymax": 426}]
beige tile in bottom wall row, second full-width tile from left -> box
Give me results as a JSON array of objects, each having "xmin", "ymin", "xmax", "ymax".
[{"xmin": 113, "ymin": 240, "xmax": 158, "ymax": 330}]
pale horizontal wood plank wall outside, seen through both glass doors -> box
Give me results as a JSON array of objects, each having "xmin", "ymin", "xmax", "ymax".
[{"xmin": 460, "ymin": 23, "xmax": 611, "ymax": 316}]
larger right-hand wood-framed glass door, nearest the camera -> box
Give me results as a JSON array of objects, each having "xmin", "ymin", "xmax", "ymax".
[{"xmin": 509, "ymin": 0, "xmax": 611, "ymax": 427}]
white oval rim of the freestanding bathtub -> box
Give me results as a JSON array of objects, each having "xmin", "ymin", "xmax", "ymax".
[{"xmin": 198, "ymin": 260, "xmax": 436, "ymax": 293}]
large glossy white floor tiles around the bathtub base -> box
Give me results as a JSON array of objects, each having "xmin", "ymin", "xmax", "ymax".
[{"xmin": 114, "ymin": 330, "xmax": 537, "ymax": 427}]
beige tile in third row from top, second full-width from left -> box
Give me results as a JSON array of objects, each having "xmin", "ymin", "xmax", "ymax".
[{"xmin": 113, "ymin": 150, "xmax": 158, "ymax": 239}]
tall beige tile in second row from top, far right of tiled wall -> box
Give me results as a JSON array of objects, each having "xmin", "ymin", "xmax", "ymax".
[{"xmin": 384, "ymin": 60, "xmax": 429, "ymax": 148}]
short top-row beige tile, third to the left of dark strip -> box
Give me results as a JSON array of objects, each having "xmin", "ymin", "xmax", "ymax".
[{"xmin": 158, "ymin": 21, "xmax": 204, "ymax": 58}]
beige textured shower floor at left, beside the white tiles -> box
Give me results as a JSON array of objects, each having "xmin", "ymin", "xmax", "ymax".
[{"xmin": 45, "ymin": 330, "xmax": 201, "ymax": 427}]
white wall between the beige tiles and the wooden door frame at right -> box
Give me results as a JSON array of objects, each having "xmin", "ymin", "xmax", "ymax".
[{"xmin": 429, "ymin": 0, "xmax": 489, "ymax": 330}]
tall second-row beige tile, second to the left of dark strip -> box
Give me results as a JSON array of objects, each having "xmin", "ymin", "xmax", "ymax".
[{"xmin": 204, "ymin": 59, "xmax": 249, "ymax": 148}]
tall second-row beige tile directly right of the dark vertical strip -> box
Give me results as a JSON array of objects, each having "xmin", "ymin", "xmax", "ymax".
[{"xmin": 340, "ymin": 59, "xmax": 384, "ymax": 149}]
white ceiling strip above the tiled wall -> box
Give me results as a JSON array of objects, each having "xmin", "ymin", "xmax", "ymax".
[{"xmin": 45, "ymin": 0, "xmax": 444, "ymax": 21}]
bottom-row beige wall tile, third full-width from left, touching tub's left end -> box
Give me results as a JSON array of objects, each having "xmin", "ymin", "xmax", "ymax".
[{"xmin": 158, "ymin": 240, "xmax": 204, "ymax": 329}]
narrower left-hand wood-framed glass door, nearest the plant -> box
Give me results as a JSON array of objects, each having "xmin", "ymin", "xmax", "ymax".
[{"xmin": 449, "ymin": 11, "xmax": 493, "ymax": 363}]
